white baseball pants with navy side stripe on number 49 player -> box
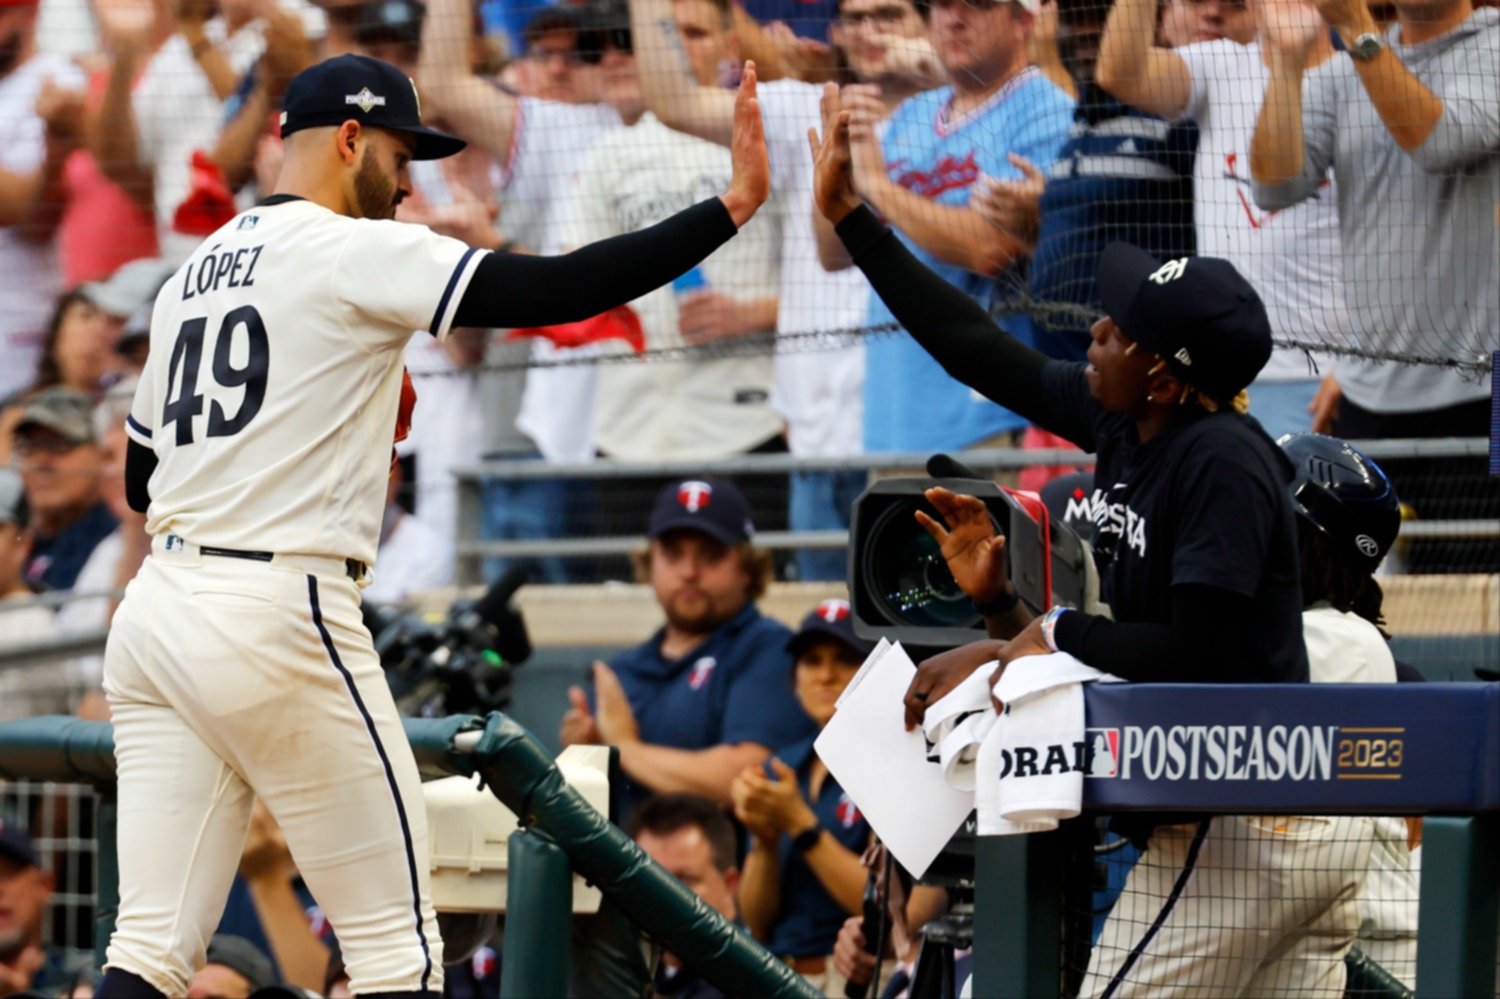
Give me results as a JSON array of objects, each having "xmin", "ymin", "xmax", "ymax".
[{"xmin": 105, "ymin": 536, "xmax": 443, "ymax": 996}]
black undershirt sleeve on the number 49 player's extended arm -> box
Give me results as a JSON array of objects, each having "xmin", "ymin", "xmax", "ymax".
[{"xmin": 453, "ymin": 198, "xmax": 737, "ymax": 327}]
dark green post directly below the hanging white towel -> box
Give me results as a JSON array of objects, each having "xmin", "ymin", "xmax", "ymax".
[{"xmin": 974, "ymin": 833, "xmax": 1064, "ymax": 999}]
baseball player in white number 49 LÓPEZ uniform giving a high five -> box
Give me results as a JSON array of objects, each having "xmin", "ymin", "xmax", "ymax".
[{"xmin": 98, "ymin": 56, "xmax": 770, "ymax": 998}]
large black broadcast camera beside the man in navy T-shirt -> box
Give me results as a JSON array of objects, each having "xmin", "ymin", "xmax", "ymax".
[{"xmin": 849, "ymin": 456, "xmax": 1098, "ymax": 648}]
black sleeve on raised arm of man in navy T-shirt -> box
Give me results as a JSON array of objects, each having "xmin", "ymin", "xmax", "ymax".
[{"xmin": 836, "ymin": 206, "xmax": 1055, "ymax": 426}]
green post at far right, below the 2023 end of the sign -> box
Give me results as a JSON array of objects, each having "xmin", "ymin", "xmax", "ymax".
[{"xmin": 1416, "ymin": 812, "xmax": 1500, "ymax": 999}]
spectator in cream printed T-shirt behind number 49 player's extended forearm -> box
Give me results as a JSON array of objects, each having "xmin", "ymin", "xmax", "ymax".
[{"xmin": 546, "ymin": 0, "xmax": 785, "ymax": 461}]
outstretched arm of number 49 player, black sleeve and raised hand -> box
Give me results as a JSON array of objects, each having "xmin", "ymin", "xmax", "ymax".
[{"xmin": 455, "ymin": 63, "xmax": 771, "ymax": 327}]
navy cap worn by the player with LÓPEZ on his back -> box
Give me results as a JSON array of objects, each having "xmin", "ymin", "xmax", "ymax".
[{"xmin": 282, "ymin": 56, "xmax": 468, "ymax": 159}]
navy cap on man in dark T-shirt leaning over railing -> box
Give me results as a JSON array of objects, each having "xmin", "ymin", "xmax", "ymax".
[{"xmin": 1098, "ymin": 243, "xmax": 1271, "ymax": 399}]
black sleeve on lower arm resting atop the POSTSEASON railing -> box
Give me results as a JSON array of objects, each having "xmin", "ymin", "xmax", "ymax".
[{"xmin": 1053, "ymin": 584, "xmax": 1265, "ymax": 684}]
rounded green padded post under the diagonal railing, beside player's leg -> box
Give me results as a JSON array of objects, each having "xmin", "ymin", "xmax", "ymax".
[{"xmin": 500, "ymin": 830, "xmax": 573, "ymax": 999}]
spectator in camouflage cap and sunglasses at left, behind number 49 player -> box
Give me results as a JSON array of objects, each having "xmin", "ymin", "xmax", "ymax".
[{"xmin": 12, "ymin": 386, "xmax": 119, "ymax": 590}]
